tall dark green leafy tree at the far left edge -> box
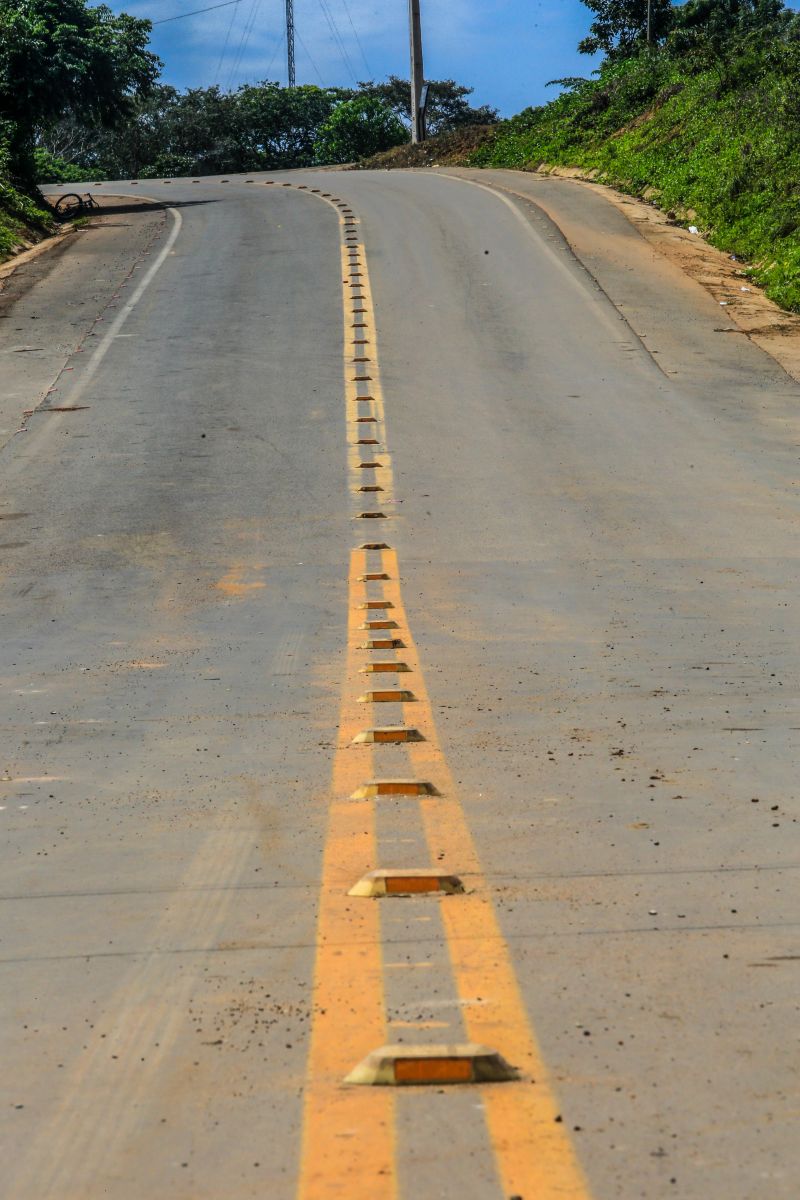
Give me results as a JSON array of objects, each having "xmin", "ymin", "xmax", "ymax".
[{"xmin": 0, "ymin": 0, "xmax": 161, "ymax": 182}]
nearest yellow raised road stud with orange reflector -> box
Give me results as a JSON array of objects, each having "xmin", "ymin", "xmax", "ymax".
[{"xmin": 344, "ymin": 1043, "xmax": 519, "ymax": 1087}]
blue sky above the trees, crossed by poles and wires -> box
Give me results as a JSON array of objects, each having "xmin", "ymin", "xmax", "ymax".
[{"xmin": 122, "ymin": 0, "xmax": 800, "ymax": 116}]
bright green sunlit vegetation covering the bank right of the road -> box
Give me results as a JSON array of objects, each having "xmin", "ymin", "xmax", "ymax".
[{"xmin": 473, "ymin": 0, "xmax": 800, "ymax": 311}]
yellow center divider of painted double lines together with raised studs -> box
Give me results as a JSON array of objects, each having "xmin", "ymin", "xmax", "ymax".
[{"xmin": 272, "ymin": 180, "xmax": 589, "ymax": 1200}]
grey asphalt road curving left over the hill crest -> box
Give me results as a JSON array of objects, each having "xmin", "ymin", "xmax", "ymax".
[{"xmin": 0, "ymin": 173, "xmax": 800, "ymax": 1200}]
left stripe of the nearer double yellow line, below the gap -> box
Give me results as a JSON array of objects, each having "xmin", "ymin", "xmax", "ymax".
[{"xmin": 297, "ymin": 551, "xmax": 397, "ymax": 1200}]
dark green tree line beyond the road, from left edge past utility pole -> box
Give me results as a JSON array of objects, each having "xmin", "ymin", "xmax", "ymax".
[{"xmin": 0, "ymin": 0, "xmax": 497, "ymax": 254}]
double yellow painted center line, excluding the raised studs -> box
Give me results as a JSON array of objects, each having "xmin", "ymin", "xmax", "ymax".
[{"xmin": 272, "ymin": 185, "xmax": 589, "ymax": 1200}]
